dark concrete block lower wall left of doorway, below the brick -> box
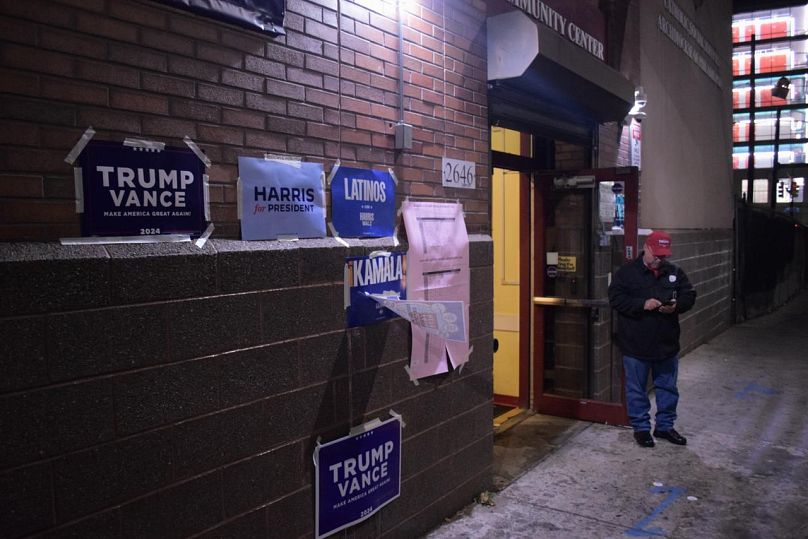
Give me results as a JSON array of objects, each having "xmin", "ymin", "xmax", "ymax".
[{"xmin": 0, "ymin": 235, "xmax": 493, "ymax": 538}]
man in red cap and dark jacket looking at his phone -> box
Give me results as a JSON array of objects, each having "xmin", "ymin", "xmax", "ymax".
[{"xmin": 609, "ymin": 230, "xmax": 696, "ymax": 447}]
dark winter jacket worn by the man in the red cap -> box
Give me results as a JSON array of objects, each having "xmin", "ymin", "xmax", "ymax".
[{"xmin": 609, "ymin": 254, "xmax": 696, "ymax": 361}]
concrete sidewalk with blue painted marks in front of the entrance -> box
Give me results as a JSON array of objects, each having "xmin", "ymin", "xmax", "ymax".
[{"xmin": 428, "ymin": 293, "xmax": 808, "ymax": 539}]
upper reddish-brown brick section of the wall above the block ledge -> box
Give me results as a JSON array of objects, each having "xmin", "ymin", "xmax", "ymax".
[{"xmin": 0, "ymin": 0, "xmax": 490, "ymax": 240}]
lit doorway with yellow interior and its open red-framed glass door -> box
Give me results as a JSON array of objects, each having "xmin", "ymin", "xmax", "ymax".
[{"xmin": 491, "ymin": 127, "xmax": 637, "ymax": 425}]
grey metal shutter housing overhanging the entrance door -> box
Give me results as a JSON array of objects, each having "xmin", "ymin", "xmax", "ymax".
[{"xmin": 488, "ymin": 10, "xmax": 634, "ymax": 123}]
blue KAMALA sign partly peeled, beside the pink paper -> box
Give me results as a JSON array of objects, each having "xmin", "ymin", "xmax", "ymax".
[{"xmin": 345, "ymin": 253, "xmax": 407, "ymax": 327}]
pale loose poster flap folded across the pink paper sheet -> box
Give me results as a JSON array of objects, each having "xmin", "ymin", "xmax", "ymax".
[{"xmin": 370, "ymin": 294, "xmax": 467, "ymax": 342}]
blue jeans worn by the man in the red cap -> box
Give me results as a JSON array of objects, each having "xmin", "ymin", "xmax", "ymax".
[{"xmin": 623, "ymin": 356, "xmax": 679, "ymax": 432}]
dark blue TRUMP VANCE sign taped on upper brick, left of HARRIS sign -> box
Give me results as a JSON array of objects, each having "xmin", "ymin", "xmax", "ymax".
[{"xmin": 77, "ymin": 141, "xmax": 205, "ymax": 236}]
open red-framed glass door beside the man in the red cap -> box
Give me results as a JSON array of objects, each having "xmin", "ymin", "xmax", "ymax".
[{"xmin": 532, "ymin": 168, "xmax": 637, "ymax": 424}]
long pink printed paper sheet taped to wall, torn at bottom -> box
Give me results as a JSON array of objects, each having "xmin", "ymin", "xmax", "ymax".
[{"xmin": 401, "ymin": 200, "xmax": 470, "ymax": 379}]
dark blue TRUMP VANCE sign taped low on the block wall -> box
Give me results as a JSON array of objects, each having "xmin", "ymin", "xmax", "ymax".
[{"xmin": 314, "ymin": 416, "xmax": 401, "ymax": 539}]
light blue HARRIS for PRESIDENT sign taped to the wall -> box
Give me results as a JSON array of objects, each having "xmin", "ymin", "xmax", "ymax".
[{"xmin": 238, "ymin": 157, "xmax": 325, "ymax": 240}]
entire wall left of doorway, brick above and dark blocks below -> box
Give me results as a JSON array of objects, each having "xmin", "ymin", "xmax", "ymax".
[{"xmin": 0, "ymin": 0, "xmax": 492, "ymax": 537}]
